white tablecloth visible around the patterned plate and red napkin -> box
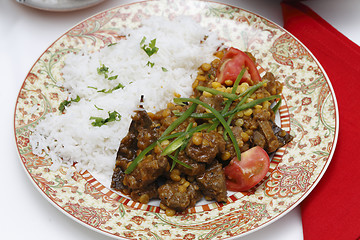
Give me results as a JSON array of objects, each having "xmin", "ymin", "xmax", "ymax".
[{"xmin": 0, "ymin": 0, "xmax": 360, "ymax": 240}]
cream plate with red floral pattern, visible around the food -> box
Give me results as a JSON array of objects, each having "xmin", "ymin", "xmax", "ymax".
[{"xmin": 15, "ymin": 0, "xmax": 339, "ymax": 240}]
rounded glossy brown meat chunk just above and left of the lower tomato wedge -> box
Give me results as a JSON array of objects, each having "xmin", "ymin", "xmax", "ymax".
[{"xmin": 185, "ymin": 131, "xmax": 226, "ymax": 163}]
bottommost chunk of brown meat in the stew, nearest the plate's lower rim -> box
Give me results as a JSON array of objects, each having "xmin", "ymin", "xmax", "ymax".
[{"xmin": 158, "ymin": 180, "xmax": 202, "ymax": 212}]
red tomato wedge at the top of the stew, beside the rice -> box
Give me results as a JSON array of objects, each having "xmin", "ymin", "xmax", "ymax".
[{"xmin": 217, "ymin": 47, "xmax": 261, "ymax": 85}]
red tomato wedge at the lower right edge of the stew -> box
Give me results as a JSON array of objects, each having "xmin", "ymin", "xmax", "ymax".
[{"xmin": 224, "ymin": 146, "xmax": 270, "ymax": 192}]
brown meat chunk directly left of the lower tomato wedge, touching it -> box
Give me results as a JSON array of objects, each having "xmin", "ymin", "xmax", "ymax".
[{"xmin": 196, "ymin": 162, "xmax": 227, "ymax": 202}]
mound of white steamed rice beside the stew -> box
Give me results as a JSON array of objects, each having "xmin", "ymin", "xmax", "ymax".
[{"xmin": 30, "ymin": 17, "xmax": 220, "ymax": 186}]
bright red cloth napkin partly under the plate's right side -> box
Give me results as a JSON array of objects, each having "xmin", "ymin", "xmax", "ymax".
[{"xmin": 281, "ymin": 1, "xmax": 360, "ymax": 240}]
